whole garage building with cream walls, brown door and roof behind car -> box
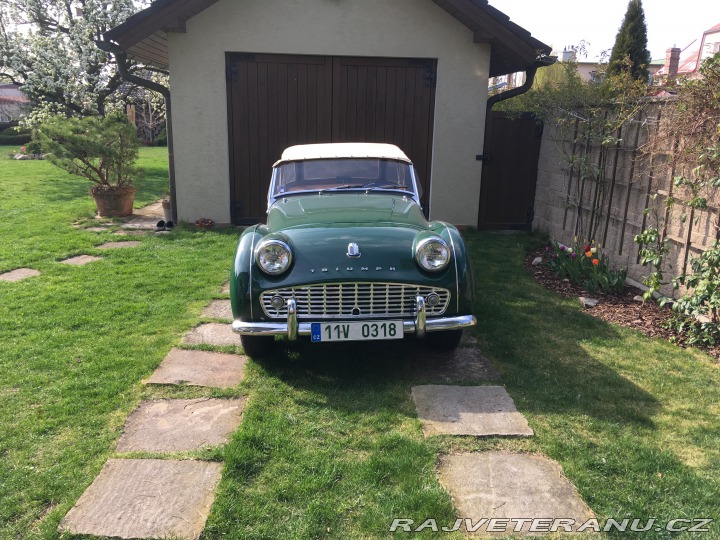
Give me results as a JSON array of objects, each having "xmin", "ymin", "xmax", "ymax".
[{"xmin": 104, "ymin": 0, "xmax": 550, "ymax": 226}]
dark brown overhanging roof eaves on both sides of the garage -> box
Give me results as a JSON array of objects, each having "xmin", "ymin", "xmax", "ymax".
[{"xmin": 103, "ymin": 0, "xmax": 551, "ymax": 77}]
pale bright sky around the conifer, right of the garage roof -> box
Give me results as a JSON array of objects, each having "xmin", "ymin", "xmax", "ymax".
[{"xmin": 489, "ymin": 0, "xmax": 720, "ymax": 61}]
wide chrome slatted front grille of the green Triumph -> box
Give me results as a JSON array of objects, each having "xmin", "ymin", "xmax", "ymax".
[{"xmin": 260, "ymin": 283, "xmax": 450, "ymax": 319}]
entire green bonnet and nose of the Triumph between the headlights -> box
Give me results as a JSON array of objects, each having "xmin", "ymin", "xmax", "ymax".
[{"xmin": 258, "ymin": 194, "xmax": 454, "ymax": 286}]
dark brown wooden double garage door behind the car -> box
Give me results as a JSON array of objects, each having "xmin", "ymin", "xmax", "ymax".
[{"xmin": 227, "ymin": 53, "xmax": 436, "ymax": 225}]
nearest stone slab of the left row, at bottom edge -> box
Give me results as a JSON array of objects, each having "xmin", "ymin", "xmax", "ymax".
[{"xmin": 58, "ymin": 459, "xmax": 222, "ymax": 540}]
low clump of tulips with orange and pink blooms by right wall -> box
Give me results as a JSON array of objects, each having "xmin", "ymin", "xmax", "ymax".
[{"xmin": 545, "ymin": 239, "xmax": 627, "ymax": 294}]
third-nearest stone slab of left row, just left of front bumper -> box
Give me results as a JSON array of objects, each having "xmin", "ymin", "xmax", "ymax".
[{"xmin": 146, "ymin": 349, "xmax": 247, "ymax": 388}]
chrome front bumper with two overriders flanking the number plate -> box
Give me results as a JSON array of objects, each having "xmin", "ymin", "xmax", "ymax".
[{"xmin": 232, "ymin": 296, "xmax": 477, "ymax": 341}]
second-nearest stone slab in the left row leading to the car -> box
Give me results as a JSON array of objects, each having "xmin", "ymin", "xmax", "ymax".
[{"xmin": 116, "ymin": 398, "xmax": 246, "ymax": 452}]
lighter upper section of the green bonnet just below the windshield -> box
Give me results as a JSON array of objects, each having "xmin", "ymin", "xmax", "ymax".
[{"xmin": 267, "ymin": 192, "xmax": 428, "ymax": 232}]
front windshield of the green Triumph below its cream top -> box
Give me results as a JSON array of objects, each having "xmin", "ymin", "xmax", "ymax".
[{"xmin": 271, "ymin": 158, "xmax": 415, "ymax": 197}]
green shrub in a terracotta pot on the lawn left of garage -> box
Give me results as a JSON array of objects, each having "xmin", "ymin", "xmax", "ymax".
[{"xmin": 37, "ymin": 114, "xmax": 140, "ymax": 217}]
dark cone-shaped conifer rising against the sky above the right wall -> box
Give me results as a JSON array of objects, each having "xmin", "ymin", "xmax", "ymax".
[{"xmin": 608, "ymin": 0, "xmax": 650, "ymax": 81}]
